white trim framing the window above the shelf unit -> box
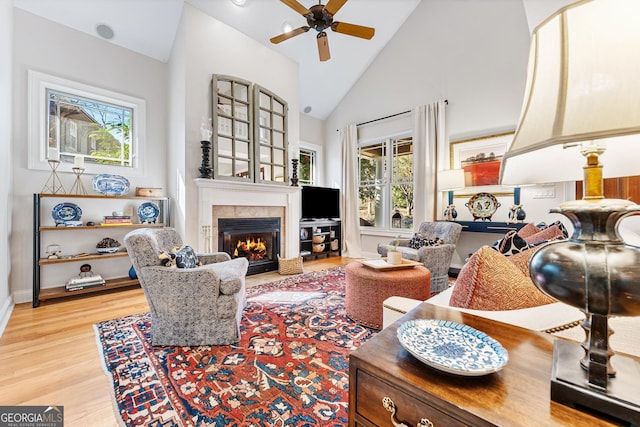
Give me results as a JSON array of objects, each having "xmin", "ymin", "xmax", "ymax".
[{"xmin": 28, "ymin": 70, "xmax": 147, "ymax": 177}]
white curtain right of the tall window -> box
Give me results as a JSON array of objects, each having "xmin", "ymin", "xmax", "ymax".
[{"xmin": 411, "ymin": 101, "xmax": 448, "ymax": 229}]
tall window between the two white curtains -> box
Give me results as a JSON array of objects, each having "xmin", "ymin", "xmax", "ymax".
[{"xmin": 358, "ymin": 135, "xmax": 414, "ymax": 231}]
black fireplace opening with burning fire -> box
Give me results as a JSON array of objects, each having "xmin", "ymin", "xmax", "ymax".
[{"xmin": 218, "ymin": 218, "xmax": 280, "ymax": 275}]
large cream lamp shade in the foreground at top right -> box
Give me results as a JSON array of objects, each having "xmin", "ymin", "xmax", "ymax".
[{"xmin": 500, "ymin": 0, "xmax": 640, "ymax": 185}]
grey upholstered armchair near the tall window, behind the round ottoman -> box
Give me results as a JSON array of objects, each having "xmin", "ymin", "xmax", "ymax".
[{"xmin": 378, "ymin": 221, "xmax": 462, "ymax": 292}]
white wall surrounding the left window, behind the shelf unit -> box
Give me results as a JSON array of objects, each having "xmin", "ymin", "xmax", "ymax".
[{"xmin": 12, "ymin": 8, "xmax": 167, "ymax": 302}]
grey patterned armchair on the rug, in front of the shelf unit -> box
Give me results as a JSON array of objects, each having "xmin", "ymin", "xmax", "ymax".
[{"xmin": 124, "ymin": 227, "xmax": 249, "ymax": 346}]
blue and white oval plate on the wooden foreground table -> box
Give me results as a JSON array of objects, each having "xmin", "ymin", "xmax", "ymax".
[{"xmin": 398, "ymin": 319, "xmax": 509, "ymax": 376}]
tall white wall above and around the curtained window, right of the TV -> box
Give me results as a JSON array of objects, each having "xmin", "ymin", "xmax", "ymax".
[{"xmin": 325, "ymin": 0, "xmax": 565, "ymax": 265}]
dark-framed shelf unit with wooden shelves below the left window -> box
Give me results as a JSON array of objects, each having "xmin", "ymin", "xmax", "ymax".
[{"xmin": 32, "ymin": 194, "xmax": 170, "ymax": 308}]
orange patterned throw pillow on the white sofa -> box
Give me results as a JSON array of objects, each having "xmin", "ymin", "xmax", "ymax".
[{"xmin": 449, "ymin": 246, "xmax": 555, "ymax": 311}]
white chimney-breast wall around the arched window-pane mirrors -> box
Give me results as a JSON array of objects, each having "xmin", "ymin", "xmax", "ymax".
[{"xmin": 169, "ymin": 3, "xmax": 300, "ymax": 244}]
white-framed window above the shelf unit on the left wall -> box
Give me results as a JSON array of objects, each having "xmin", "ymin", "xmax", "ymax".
[{"xmin": 29, "ymin": 71, "xmax": 145, "ymax": 176}]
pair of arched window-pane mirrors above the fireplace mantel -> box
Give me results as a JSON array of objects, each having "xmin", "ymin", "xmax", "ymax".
[{"xmin": 212, "ymin": 74, "xmax": 289, "ymax": 184}]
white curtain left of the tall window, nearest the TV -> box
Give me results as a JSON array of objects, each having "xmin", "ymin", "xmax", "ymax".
[{"xmin": 340, "ymin": 124, "xmax": 362, "ymax": 258}]
